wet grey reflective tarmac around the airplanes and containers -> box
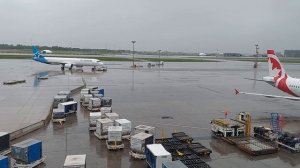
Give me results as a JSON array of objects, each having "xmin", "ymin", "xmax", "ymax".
[{"xmin": 0, "ymin": 60, "xmax": 300, "ymax": 168}]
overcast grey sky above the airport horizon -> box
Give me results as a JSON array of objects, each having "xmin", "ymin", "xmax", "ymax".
[{"xmin": 0, "ymin": 0, "xmax": 300, "ymax": 53}]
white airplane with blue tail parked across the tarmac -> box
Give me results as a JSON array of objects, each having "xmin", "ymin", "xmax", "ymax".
[{"xmin": 32, "ymin": 46, "xmax": 103, "ymax": 70}]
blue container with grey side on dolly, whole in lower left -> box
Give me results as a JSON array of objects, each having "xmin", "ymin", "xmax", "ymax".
[{"xmin": 11, "ymin": 139, "xmax": 42, "ymax": 164}]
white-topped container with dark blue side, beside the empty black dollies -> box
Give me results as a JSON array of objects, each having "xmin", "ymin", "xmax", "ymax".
[{"xmin": 145, "ymin": 144, "xmax": 172, "ymax": 168}]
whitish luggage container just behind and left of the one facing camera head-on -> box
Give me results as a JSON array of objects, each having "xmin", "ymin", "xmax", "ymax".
[{"xmin": 94, "ymin": 118, "xmax": 114, "ymax": 139}]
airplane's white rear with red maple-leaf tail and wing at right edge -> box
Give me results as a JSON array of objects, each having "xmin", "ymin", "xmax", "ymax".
[{"xmin": 235, "ymin": 50, "xmax": 300, "ymax": 100}]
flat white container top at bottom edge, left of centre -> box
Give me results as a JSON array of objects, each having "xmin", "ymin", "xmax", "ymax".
[{"xmin": 64, "ymin": 154, "xmax": 86, "ymax": 168}]
